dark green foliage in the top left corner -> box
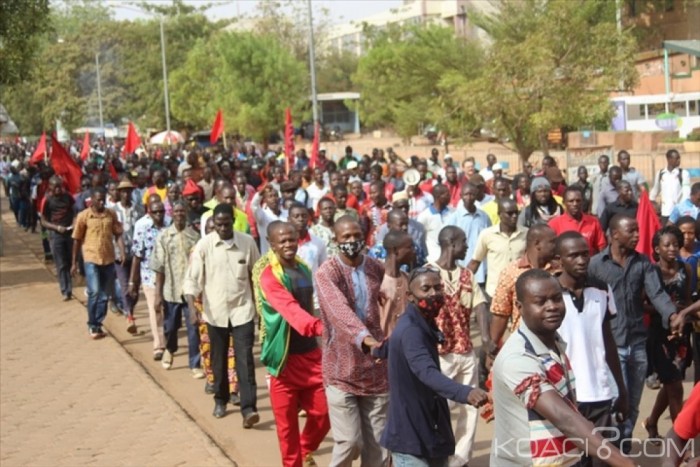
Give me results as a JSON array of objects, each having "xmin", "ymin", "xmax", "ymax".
[{"xmin": 0, "ymin": 0, "xmax": 50, "ymax": 85}]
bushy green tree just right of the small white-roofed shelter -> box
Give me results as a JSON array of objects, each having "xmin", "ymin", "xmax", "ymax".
[{"xmin": 352, "ymin": 25, "xmax": 482, "ymax": 139}]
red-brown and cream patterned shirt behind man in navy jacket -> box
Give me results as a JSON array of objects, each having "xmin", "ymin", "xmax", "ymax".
[{"xmin": 429, "ymin": 263, "xmax": 486, "ymax": 355}]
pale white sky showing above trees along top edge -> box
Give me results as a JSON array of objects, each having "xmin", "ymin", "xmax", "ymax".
[{"xmin": 105, "ymin": 0, "xmax": 403, "ymax": 24}]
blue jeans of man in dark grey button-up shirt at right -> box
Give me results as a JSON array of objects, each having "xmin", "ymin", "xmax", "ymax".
[{"xmin": 617, "ymin": 342, "xmax": 647, "ymax": 439}]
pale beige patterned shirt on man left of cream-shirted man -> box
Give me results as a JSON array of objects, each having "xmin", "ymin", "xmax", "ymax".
[{"xmin": 150, "ymin": 225, "xmax": 199, "ymax": 303}]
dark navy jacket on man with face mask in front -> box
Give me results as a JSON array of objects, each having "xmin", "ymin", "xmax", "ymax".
[{"xmin": 378, "ymin": 304, "xmax": 472, "ymax": 458}]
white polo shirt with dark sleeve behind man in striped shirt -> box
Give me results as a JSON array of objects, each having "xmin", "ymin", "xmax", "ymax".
[{"xmin": 559, "ymin": 279, "xmax": 617, "ymax": 402}]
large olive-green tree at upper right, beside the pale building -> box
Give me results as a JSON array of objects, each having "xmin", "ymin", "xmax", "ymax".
[{"xmin": 460, "ymin": 0, "xmax": 636, "ymax": 160}]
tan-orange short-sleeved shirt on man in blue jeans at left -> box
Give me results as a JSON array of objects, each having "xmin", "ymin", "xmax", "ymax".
[{"xmin": 73, "ymin": 208, "xmax": 123, "ymax": 266}]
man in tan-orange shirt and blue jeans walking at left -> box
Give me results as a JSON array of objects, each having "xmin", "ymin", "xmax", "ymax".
[{"xmin": 71, "ymin": 188, "xmax": 124, "ymax": 339}]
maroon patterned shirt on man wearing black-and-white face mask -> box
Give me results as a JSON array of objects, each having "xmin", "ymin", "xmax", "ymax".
[{"xmin": 316, "ymin": 256, "xmax": 389, "ymax": 396}]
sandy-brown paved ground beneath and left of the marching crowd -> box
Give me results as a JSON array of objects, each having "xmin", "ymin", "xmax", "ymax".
[{"xmin": 0, "ymin": 199, "xmax": 692, "ymax": 467}]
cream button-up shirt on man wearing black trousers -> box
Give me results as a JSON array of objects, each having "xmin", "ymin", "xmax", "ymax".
[{"xmin": 183, "ymin": 231, "xmax": 260, "ymax": 327}]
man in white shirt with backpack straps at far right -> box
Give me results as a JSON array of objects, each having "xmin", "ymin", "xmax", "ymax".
[{"xmin": 649, "ymin": 149, "xmax": 690, "ymax": 225}]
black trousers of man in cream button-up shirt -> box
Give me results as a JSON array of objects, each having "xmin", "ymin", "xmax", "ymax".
[{"xmin": 207, "ymin": 320, "xmax": 258, "ymax": 417}]
